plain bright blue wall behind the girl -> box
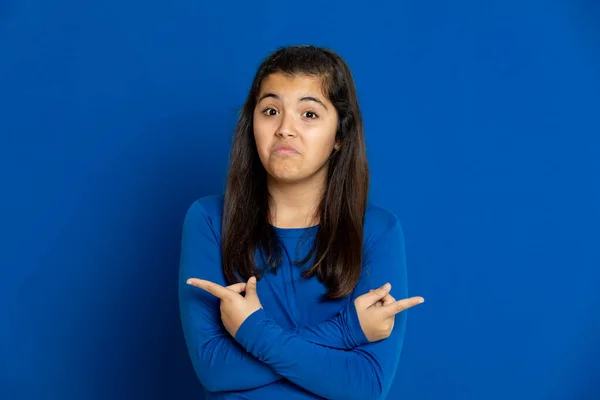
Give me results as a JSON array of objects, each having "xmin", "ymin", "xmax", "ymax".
[{"xmin": 0, "ymin": 0, "xmax": 600, "ymax": 400}]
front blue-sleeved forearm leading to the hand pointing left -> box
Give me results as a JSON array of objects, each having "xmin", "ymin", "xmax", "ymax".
[{"xmin": 236, "ymin": 310, "xmax": 402, "ymax": 399}]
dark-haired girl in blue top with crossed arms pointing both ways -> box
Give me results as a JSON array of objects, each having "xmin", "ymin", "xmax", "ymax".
[{"xmin": 179, "ymin": 46, "xmax": 423, "ymax": 400}]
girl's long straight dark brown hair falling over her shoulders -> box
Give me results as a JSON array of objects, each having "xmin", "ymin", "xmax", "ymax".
[{"xmin": 222, "ymin": 46, "xmax": 369, "ymax": 299}]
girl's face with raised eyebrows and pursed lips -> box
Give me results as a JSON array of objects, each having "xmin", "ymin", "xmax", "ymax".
[{"xmin": 254, "ymin": 73, "xmax": 339, "ymax": 183}]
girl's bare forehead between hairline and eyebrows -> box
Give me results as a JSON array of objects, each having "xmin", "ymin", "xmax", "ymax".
[{"xmin": 259, "ymin": 73, "xmax": 326, "ymax": 99}]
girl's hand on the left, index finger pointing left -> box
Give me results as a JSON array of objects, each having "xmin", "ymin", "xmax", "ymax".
[{"xmin": 187, "ymin": 277, "xmax": 262, "ymax": 338}]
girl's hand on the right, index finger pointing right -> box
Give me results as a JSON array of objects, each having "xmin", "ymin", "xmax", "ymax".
[{"xmin": 354, "ymin": 283, "xmax": 425, "ymax": 342}]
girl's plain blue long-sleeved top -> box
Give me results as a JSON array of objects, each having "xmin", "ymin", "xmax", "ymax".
[{"xmin": 179, "ymin": 196, "xmax": 408, "ymax": 400}]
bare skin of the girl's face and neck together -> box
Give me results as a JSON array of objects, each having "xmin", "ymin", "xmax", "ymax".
[{"xmin": 253, "ymin": 74, "xmax": 340, "ymax": 228}]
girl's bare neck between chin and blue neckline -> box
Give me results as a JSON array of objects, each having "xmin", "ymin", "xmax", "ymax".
[{"xmin": 267, "ymin": 175, "xmax": 324, "ymax": 228}]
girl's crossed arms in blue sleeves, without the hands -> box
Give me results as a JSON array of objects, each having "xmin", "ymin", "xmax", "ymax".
[{"xmin": 179, "ymin": 203, "xmax": 406, "ymax": 399}]
